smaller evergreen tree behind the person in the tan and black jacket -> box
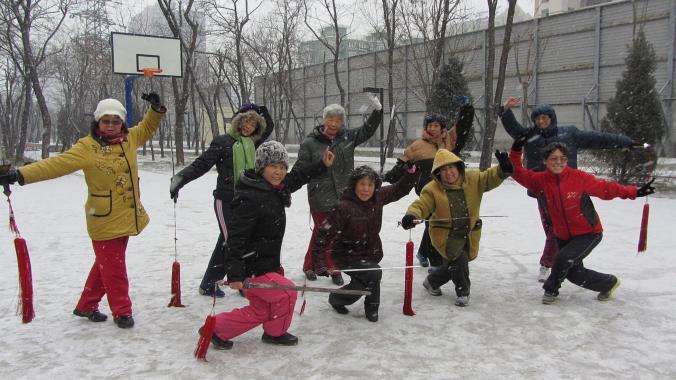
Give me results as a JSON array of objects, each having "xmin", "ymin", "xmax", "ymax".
[{"xmin": 427, "ymin": 57, "xmax": 470, "ymax": 127}]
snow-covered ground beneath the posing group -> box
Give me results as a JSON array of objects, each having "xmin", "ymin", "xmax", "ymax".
[{"xmin": 0, "ymin": 154, "xmax": 676, "ymax": 379}]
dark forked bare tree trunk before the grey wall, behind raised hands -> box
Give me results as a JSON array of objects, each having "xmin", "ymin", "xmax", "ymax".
[{"xmin": 479, "ymin": 0, "xmax": 516, "ymax": 170}]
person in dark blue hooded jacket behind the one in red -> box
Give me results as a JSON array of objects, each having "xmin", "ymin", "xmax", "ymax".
[{"xmin": 498, "ymin": 97, "xmax": 640, "ymax": 282}]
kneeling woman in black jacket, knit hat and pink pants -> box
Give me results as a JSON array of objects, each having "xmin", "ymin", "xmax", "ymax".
[{"xmin": 212, "ymin": 141, "xmax": 333, "ymax": 348}]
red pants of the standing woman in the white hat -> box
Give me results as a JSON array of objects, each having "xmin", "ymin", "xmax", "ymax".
[{"xmin": 77, "ymin": 236, "xmax": 132, "ymax": 318}]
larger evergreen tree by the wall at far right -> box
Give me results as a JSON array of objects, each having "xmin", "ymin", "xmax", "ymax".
[{"xmin": 595, "ymin": 29, "xmax": 665, "ymax": 184}]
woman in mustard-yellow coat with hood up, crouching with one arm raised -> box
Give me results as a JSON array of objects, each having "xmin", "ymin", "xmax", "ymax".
[{"xmin": 401, "ymin": 149, "xmax": 512, "ymax": 307}]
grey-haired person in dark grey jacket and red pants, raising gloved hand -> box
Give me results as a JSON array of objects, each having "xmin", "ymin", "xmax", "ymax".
[{"xmin": 296, "ymin": 96, "xmax": 382, "ymax": 285}]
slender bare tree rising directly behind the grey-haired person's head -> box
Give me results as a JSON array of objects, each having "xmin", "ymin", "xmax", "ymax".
[{"xmin": 303, "ymin": 0, "xmax": 351, "ymax": 105}]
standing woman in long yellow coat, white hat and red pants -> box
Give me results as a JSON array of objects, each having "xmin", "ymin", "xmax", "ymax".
[{"xmin": 0, "ymin": 93, "xmax": 166, "ymax": 328}]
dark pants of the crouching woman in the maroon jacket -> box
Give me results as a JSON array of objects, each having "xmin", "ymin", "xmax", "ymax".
[{"xmin": 329, "ymin": 261, "xmax": 383, "ymax": 306}]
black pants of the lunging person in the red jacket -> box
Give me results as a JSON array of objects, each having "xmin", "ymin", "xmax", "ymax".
[{"xmin": 542, "ymin": 234, "xmax": 615, "ymax": 295}]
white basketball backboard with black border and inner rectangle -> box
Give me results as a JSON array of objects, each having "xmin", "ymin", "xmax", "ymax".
[{"xmin": 110, "ymin": 32, "xmax": 183, "ymax": 77}]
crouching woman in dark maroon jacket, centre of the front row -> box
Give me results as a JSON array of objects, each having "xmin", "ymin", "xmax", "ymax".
[{"xmin": 313, "ymin": 164, "xmax": 419, "ymax": 322}]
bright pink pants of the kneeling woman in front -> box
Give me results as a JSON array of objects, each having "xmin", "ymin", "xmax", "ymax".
[{"xmin": 214, "ymin": 272, "xmax": 298, "ymax": 340}]
